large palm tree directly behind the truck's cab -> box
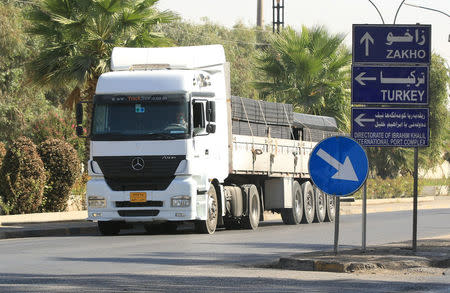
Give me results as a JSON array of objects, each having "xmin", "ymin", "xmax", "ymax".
[{"xmin": 25, "ymin": 0, "xmax": 177, "ymax": 108}]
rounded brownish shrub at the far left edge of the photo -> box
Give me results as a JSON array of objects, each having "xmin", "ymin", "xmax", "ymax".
[{"xmin": 0, "ymin": 137, "xmax": 46, "ymax": 214}]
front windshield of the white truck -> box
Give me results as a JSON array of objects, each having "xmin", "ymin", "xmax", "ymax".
[{"xmin": 92, "ymin": 95, "xmax": 190, "ymax": 140}]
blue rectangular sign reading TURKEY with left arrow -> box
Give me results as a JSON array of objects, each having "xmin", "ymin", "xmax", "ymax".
[{"xmin": 352, "ymin": 65, "xmax": 429, "ymax": 105}]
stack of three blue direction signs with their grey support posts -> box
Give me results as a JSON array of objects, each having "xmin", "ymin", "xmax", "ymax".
[{"xmin": 352, "ymin": 24, "xmax": 431, "ymax": 251}]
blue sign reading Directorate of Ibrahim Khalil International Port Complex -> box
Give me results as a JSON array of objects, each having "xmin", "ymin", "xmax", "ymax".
[{"xmin": 352, "ymin": 107, "xmax": 429, "ymax": 147}]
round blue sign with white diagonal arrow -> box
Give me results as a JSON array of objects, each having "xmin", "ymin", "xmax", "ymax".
[{"xmin": 308, "ymin": 136, "xmax": 369, "ymax": 196}]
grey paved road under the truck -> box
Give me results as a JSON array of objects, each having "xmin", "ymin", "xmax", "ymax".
[{"xmin": 0, "ymin": 209, "xmax": 450, "ymax": 292}]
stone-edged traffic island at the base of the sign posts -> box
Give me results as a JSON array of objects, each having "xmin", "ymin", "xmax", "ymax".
[{"xmin": 278, "ymin": 234, "xmax": 450, "ymax": 273}]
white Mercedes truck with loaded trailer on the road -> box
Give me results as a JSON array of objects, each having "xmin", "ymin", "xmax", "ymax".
[{"xmin": 76, "ymin": 45, "xmax": 336, "ymax": 235}]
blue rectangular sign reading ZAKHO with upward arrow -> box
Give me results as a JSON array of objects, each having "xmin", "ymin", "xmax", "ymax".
[{"xmin": 353, "ymin": 24, "xmax": 431, "ymax": 64}]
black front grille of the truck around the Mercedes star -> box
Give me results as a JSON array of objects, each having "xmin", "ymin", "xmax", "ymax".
[{"xmin": 93, "ymin": 155, "xmax": 186, "ymax": 191}]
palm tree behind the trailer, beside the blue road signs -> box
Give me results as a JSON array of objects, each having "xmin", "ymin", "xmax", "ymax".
[{"xmin": 254, "ymin": 27, "xmax": 351, "ymax": 125}]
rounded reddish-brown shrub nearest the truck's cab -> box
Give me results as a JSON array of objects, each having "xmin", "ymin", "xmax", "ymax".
[{"xmin": 38, "ymin": 138, "xmax": 81, "ymax": 212}]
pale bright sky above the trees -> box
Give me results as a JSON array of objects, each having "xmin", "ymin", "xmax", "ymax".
[{"xmin": 158, "ymin": 0, "xmax": 450, "ymax": 64}]
